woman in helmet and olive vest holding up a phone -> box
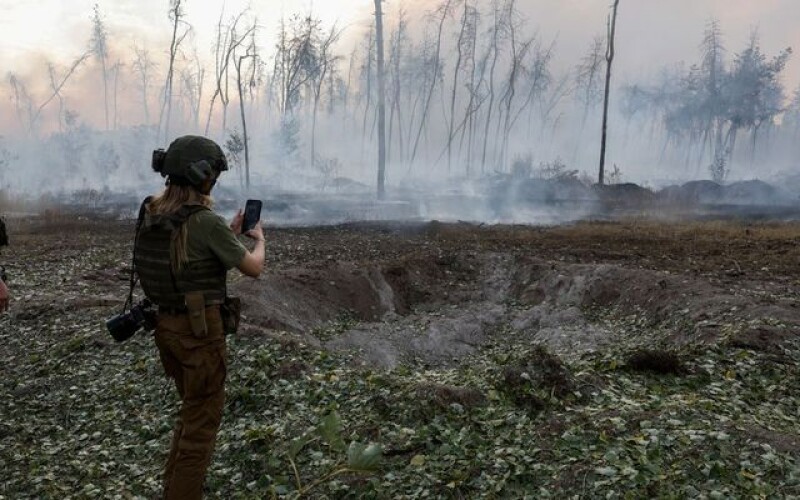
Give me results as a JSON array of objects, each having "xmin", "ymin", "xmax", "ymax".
[{"xmin": 134, "ymin": 136, "xmax": 264, "ymax": 499}]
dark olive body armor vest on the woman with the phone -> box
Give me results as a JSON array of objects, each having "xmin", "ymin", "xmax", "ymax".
[{"xmin": 134, "ymin": 205, "xmax": 227, "ymax": 308}]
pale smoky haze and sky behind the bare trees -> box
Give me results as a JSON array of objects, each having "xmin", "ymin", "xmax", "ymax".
[{"xmin": 0, "ymin": 0, "xmax": 800, "ymax": 223}]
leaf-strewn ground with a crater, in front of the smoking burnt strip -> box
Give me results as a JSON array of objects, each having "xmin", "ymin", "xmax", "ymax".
[{"xmin": 0, "ymin": 217, "xmax": 800, "ymax": 498}]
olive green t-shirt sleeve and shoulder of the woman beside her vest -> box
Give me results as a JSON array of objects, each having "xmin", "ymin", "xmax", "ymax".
[{"xmin": 186, "ymin": 210, "xmax": 247, "ymax": 270}]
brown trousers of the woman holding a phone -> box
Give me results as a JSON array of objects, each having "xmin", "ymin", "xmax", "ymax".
[{"xmin": 155, "ymin": 306, "xmax": 226, "ymax": 500}]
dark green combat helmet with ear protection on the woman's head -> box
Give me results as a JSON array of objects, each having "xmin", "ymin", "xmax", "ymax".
[{"xmin": 152, "ymin": 135, "xmax": 228, "ymax": 188}]
